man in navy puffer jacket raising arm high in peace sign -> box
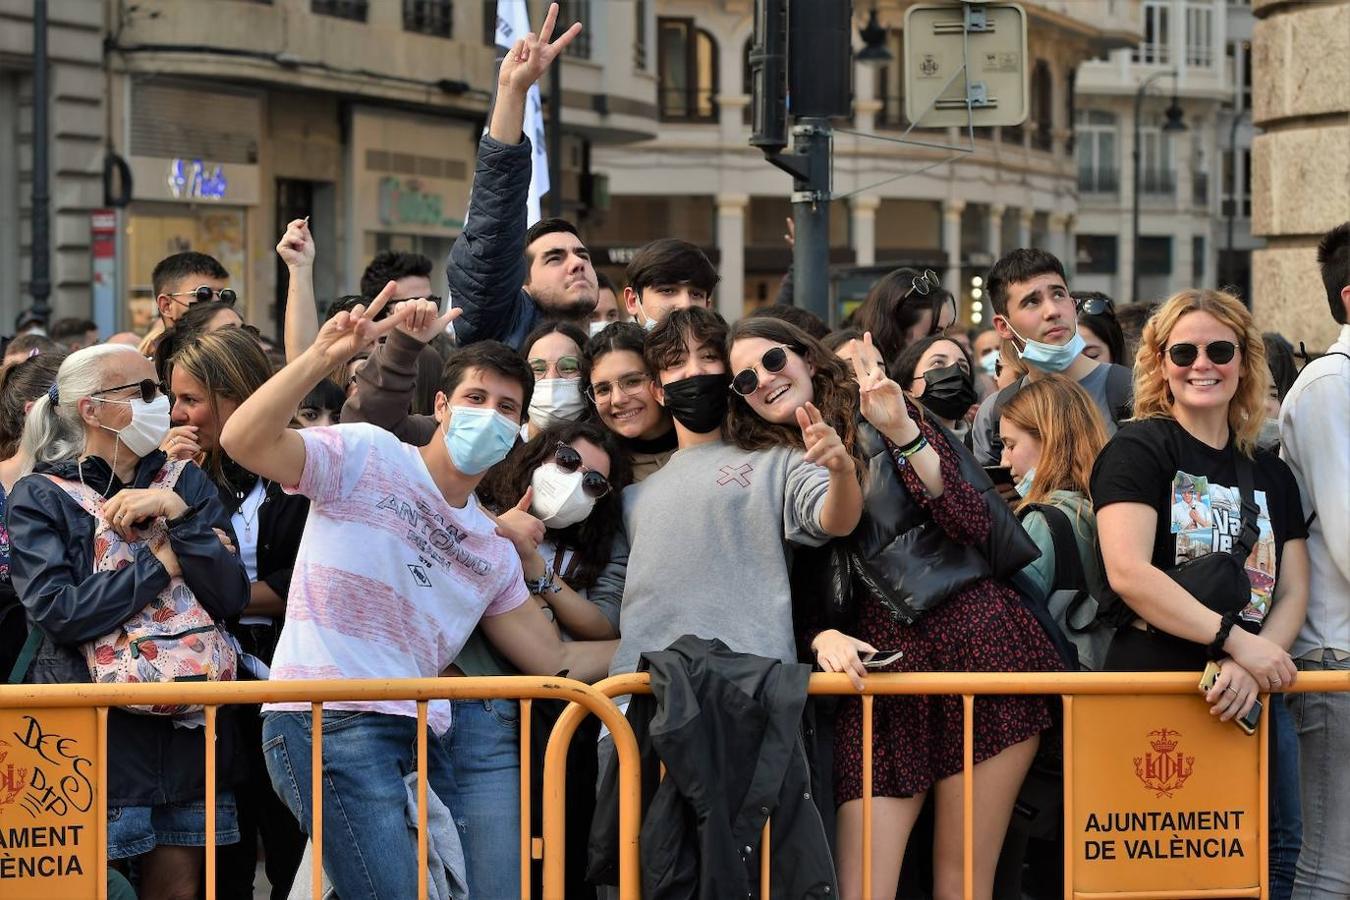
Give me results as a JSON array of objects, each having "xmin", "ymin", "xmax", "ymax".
[{"xmin": 446, "ymin": 4, "xmax": 599, "ymax": 348}]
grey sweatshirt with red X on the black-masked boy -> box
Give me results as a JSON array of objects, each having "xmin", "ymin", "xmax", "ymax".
[{"xmin": 590, "ymin": 441, "xmax": 830, "ymax": 675}]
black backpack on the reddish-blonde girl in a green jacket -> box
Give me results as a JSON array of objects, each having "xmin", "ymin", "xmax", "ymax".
[{"xmin": 1018, "ymin": 503, "xmax": 1115, "ymax": 672}]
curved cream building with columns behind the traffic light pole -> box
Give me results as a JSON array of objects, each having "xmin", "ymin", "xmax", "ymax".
[{"xmin": 585, "ymin": 0, "xmax": 1138, "ymax": 320}]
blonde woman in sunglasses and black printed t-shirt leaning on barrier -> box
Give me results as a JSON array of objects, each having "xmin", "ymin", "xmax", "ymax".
[{"xmin": 1092, "ymin": 290, "xmax": 1308, "ymax": 896}]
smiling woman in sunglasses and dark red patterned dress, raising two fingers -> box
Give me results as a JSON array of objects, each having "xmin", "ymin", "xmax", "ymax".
[{"xmin": 728, "ymin": 320, "xmax": 1060, "ymax": 897}]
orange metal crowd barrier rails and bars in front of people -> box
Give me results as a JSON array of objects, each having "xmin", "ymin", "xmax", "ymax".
[{"xmin": 0, "ymin": 672, "xmax": 1350, "ymax": 900}]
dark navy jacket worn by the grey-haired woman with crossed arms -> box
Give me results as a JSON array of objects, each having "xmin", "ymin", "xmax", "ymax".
[{"xmin": 8, "ymin": 451, "xmax": 248, "ymax": 807}]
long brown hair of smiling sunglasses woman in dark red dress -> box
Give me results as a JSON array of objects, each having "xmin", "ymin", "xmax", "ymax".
[{"xmin": 722, "ymin": 317, "xmax": 863, "ymax": 471}]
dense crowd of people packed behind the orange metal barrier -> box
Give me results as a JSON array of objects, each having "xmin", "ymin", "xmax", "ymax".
[{"xmin": 0, "ymin": 5, "xmax": 1350, "ymax": 900}]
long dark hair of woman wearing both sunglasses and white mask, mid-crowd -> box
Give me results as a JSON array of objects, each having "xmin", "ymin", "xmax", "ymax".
[{"xmin": 477, "ymin": 422, "xmax": 633, "ymax": 590}]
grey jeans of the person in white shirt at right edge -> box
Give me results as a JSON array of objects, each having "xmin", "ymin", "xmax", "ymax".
[{"xmin": 1289, "ymin": 650, "xmax": 1350, "ymax": 900}]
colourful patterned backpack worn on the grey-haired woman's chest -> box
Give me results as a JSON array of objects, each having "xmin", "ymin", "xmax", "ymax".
[{"xmin": 47, "ymin": 460, "xmax": 238, "ymax": 715}]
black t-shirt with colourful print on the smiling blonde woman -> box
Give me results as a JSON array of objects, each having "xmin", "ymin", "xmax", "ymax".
[{"xmin": 1092, "ymin": 418, "xmax": 1308, "ymax": 631}]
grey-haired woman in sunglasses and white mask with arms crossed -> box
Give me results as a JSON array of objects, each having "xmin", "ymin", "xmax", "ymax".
[{"xmin": 8, "ymin": 344, "xmax": 248, "ymax": 897}]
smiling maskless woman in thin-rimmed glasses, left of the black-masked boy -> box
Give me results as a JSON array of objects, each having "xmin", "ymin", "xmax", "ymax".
[{"xmin": 586, "ymin": 322, "xmax": 676, "ymax": 482}]
